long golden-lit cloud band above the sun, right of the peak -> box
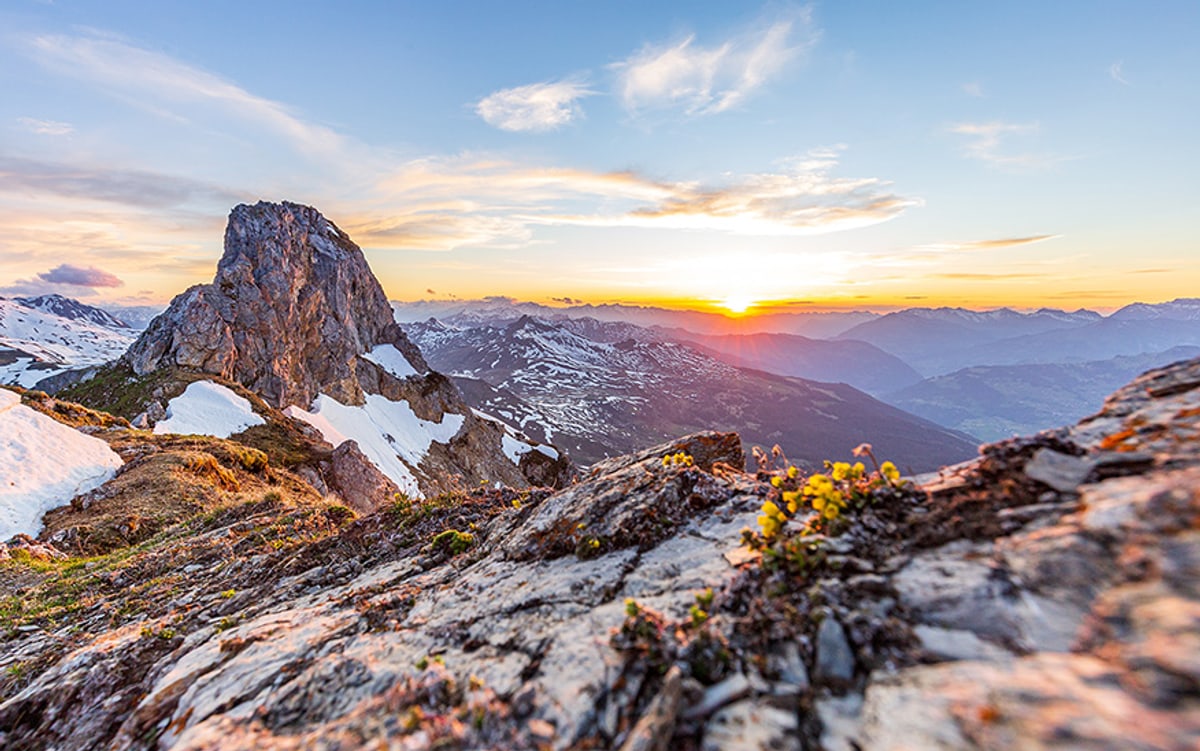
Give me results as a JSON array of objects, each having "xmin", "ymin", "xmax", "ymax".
[{"xmin": 343, "ymin": 149, "xmax": 922, "ymax": 250}]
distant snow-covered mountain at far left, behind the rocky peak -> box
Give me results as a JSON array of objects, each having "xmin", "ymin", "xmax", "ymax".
[{"xmin": 0, "ymin": 298, "xmax": 134, "ymax": 387}]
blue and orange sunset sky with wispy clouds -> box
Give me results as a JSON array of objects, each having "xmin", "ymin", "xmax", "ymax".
[{"xmin": 0, "ymin": 0, "xmax": 1200, "ymax": 313}]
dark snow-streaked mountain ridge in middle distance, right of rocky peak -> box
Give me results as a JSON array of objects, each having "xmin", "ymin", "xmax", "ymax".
[{"xmin": 406, "ymin": 317, "xmax": 976, "ymax": 471}]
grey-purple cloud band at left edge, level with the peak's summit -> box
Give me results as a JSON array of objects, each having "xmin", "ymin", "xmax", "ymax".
[{"xmin": 0, "ymin": 155, "xmax": 241, "ymax": 209}]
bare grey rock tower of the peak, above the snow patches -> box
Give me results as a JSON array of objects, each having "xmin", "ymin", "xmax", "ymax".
[{"xmin": 125, "ymin": 202, "xmax": 428, "ymax": 407}]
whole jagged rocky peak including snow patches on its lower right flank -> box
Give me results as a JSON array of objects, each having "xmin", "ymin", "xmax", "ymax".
[{"xmin": 124, "ymin": 202, "xmax": 571, "ymax": 495}]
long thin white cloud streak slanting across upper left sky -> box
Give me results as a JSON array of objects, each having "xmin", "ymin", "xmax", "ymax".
[{"xmin": 26, "ymin": 32, "xmax": 344, "ymax": 156}]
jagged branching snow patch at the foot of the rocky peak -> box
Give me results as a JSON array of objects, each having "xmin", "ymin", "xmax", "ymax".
[{"xmin": 283, "ymin": 391, "xmax": 466, "ymax": 498}]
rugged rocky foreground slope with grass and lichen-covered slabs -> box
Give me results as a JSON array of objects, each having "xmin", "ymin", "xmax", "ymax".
[{"xmin": 0, "ymin": 360, "xmax": 1200, "ymax": 750}]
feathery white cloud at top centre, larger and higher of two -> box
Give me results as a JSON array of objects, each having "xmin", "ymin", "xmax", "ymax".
[{"xmin": 612, "ymin": 8, "xmax": 820, "ymax": 114}]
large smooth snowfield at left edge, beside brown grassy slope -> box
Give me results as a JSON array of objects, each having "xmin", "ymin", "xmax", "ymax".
[{"xmin": 0, "ymin": 389, "xmax": 122, "ymax": 540}]
